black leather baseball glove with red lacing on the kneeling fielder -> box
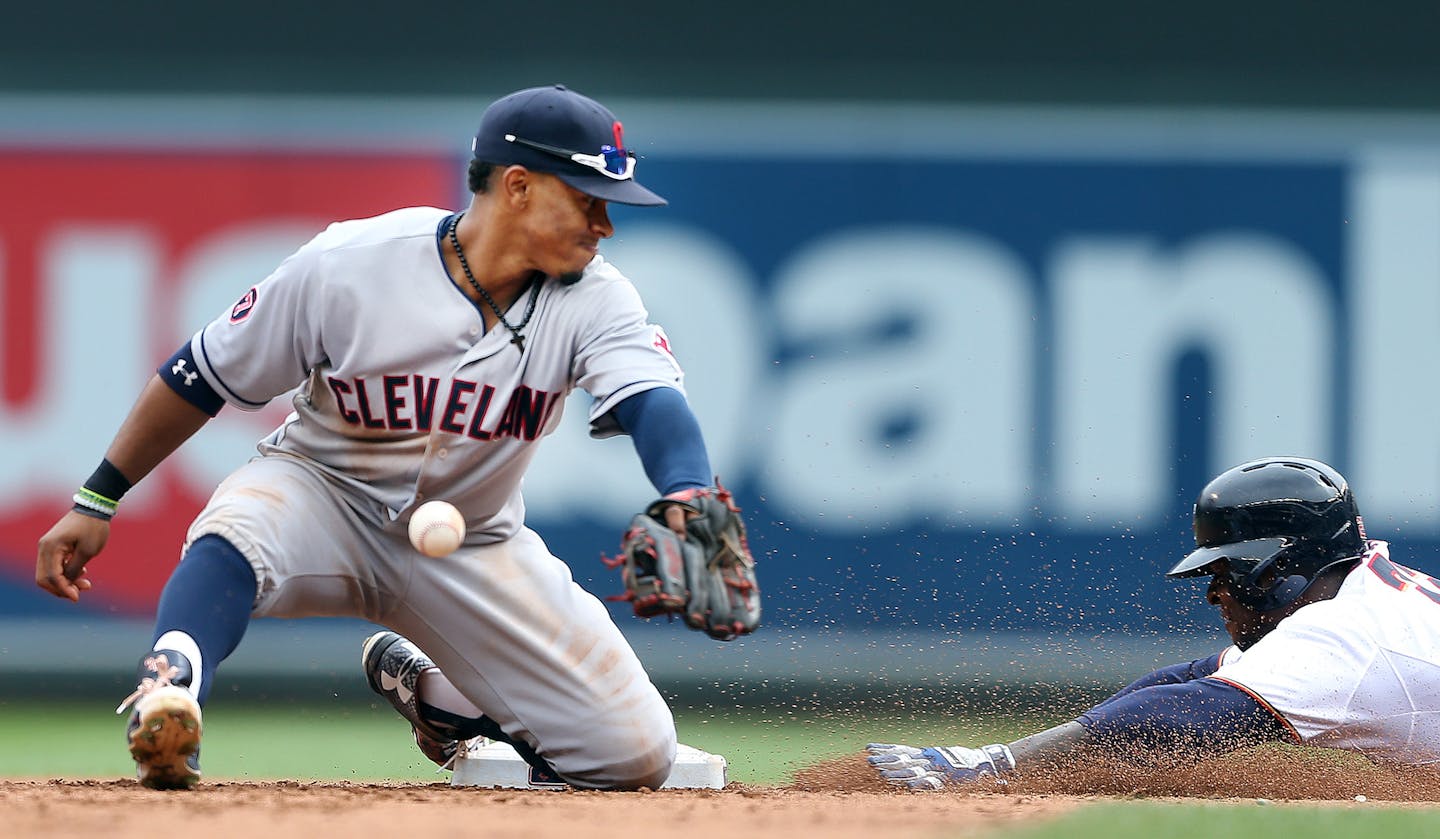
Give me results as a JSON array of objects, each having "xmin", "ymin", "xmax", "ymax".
[{"xmin": 605, "ymin": 481, "xmax": 760, "ymax": 640}]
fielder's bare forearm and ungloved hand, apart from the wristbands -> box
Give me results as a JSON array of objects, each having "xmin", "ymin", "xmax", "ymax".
[{"xmin": 35, "ymin": 367, "xmax": 219, "ymax": 602}]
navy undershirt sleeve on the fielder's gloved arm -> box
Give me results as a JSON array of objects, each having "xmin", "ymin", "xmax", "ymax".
[{"xmin": 613, "ymin": 387, "xmax": 711, "ymax": 495}]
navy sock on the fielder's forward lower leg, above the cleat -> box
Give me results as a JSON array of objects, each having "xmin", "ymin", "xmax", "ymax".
[{"xmin": 151, "ymin": 535, "xmax": 256, "ymax": 705}]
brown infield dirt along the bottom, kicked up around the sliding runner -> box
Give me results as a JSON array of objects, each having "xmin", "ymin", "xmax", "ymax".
[{"xmin": 11, "ymin": 750, "xmax": 1440, "ymax": 839}]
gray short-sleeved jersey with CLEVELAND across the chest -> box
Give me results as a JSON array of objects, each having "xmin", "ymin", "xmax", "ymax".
[{"xmin": 192, "ymin": 207, "xmax": 683, "ymax": 541}]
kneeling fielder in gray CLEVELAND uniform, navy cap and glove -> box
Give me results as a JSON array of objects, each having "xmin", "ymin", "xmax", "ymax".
[{"xmin": 36, "ymin": 85, "xmax": 759, "ymax": 789}]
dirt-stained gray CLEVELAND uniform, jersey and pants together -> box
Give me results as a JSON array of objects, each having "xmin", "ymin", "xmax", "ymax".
[{"xmin": 187, "ymin": 207, "xmax": 683, "ymax": 787}]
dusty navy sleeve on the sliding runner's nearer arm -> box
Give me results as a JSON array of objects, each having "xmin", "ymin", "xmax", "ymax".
[{"xmin": 1076, "ymin": 676, "xmax": 1293, "ymax": 761}]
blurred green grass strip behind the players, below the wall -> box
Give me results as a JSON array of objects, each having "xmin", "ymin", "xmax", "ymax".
[{"xmin": 0, "ymin": 699, "xmax": 1059, "ymax": 786}]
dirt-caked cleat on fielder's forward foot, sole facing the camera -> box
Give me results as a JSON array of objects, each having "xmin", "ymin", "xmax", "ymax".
[{"xmin": 115, "ymin": 650, "xmax": 202, "ymax": 790}]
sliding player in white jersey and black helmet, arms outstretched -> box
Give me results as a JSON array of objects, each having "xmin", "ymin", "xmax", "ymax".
[{"xmin": 867, "ymin": 458, "xmax": 1440, "ymax": 790}]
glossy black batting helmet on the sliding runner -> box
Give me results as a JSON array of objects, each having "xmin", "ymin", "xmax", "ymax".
[{"xmin": 1165, "ymin": 458, "xmax": 1365, "ymax": 612}]
